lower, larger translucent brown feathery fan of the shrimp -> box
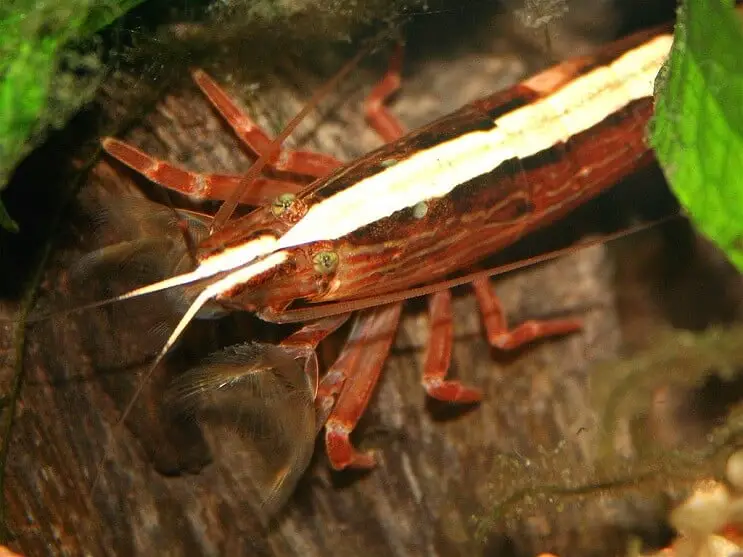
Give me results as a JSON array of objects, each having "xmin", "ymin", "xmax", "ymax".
[{"xmin": 165, "ymin": 342, "xmax": 316, "ymax": 513}]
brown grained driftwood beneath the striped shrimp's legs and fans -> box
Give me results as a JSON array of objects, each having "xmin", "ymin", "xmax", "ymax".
[{"xmin": 2, "ymin": 2, "xmax": 740, "ymax": 556}]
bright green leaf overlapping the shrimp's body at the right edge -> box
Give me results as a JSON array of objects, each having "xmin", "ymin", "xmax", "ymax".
[{"xmin": 651, "ymin": 0, "xmax": 743, "ymax": 270}]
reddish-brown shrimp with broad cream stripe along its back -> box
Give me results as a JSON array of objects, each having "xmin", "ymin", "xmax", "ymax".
[{"xmin": 93, "ymin": 23, "xmax": 672, "ymax": 503}]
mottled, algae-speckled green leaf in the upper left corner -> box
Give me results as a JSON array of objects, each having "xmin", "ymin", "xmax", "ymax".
[{"xmin": 0, "ymin": 0, "xmax": 150, "ymax": 228}]
